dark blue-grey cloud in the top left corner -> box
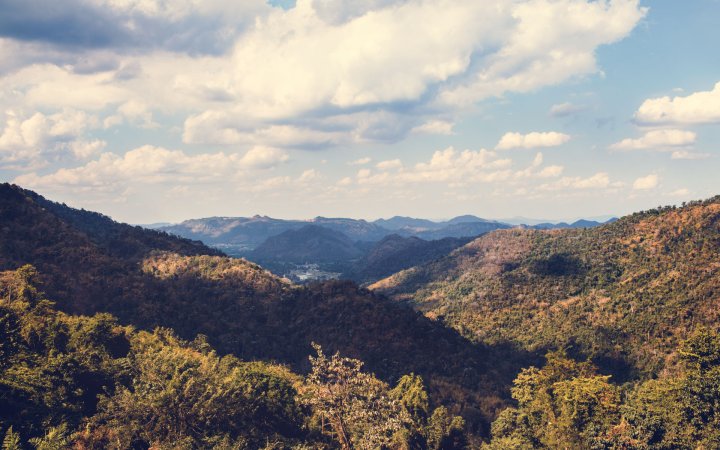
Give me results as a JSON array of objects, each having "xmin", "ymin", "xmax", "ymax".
[{"xmin": 0, "ymin": 0, "xmax": 272, "ymax": 53}]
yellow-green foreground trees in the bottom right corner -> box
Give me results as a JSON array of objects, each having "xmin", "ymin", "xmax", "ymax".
[{"xmin": 484, "ymin": 330, "xmax": 720, "ymax": 450}]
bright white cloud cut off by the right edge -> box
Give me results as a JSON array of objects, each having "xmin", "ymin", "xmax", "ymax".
[{"xmin": 635, "ymin": 82, "xmax": 720, "ymax": 124}]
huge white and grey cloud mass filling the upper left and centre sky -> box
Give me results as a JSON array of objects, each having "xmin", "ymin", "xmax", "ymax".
[{"xmin": 0, "ymin": 0, "xmax": 645, "ymax": 153}]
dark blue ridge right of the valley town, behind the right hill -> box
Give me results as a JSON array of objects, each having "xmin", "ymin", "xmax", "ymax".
[{"xmin": 344, "ymin": 234, "xmax": 472, "ymax": 283}]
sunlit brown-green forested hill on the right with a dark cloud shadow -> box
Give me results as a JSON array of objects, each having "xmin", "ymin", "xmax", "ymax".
[{"xmin": 371, "ymin": 197, "xmax": 720, "ymax": 378}]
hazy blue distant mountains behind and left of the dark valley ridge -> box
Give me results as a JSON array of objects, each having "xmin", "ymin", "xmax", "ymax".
[{"xmin": 161, "ymin": 215, "xmax": 612, "ymax": 272}]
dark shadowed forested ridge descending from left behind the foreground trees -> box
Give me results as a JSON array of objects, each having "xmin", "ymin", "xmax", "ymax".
[{"xmin": 0, "ymin": 185, "xmax": 537, "ymax": 440}]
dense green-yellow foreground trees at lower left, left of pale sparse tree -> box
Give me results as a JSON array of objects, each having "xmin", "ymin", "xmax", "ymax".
[{"xmin": 0, "ymin": 266, "xmax": 307, "ymax": 449}]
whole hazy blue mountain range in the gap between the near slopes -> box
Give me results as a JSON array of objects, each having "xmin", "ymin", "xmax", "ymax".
[{"xmin": 158, "ymin": 211, "xmax": 612, "ymax": 282}]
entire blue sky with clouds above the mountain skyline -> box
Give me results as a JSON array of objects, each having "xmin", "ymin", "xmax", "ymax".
[{"xmin": 0, "ymin": 0, "xmax": 720, "ymax": 223}]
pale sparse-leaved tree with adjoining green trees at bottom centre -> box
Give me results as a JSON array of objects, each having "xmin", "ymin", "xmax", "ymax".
[{"xmin": 303, "ymin": 344, "xmax": 466, "ymax": 450}]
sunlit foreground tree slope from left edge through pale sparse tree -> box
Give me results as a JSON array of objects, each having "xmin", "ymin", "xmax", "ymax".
[{"xmin": 0, "ymin": 266, "xmax": 465, "ymax": 450}]
